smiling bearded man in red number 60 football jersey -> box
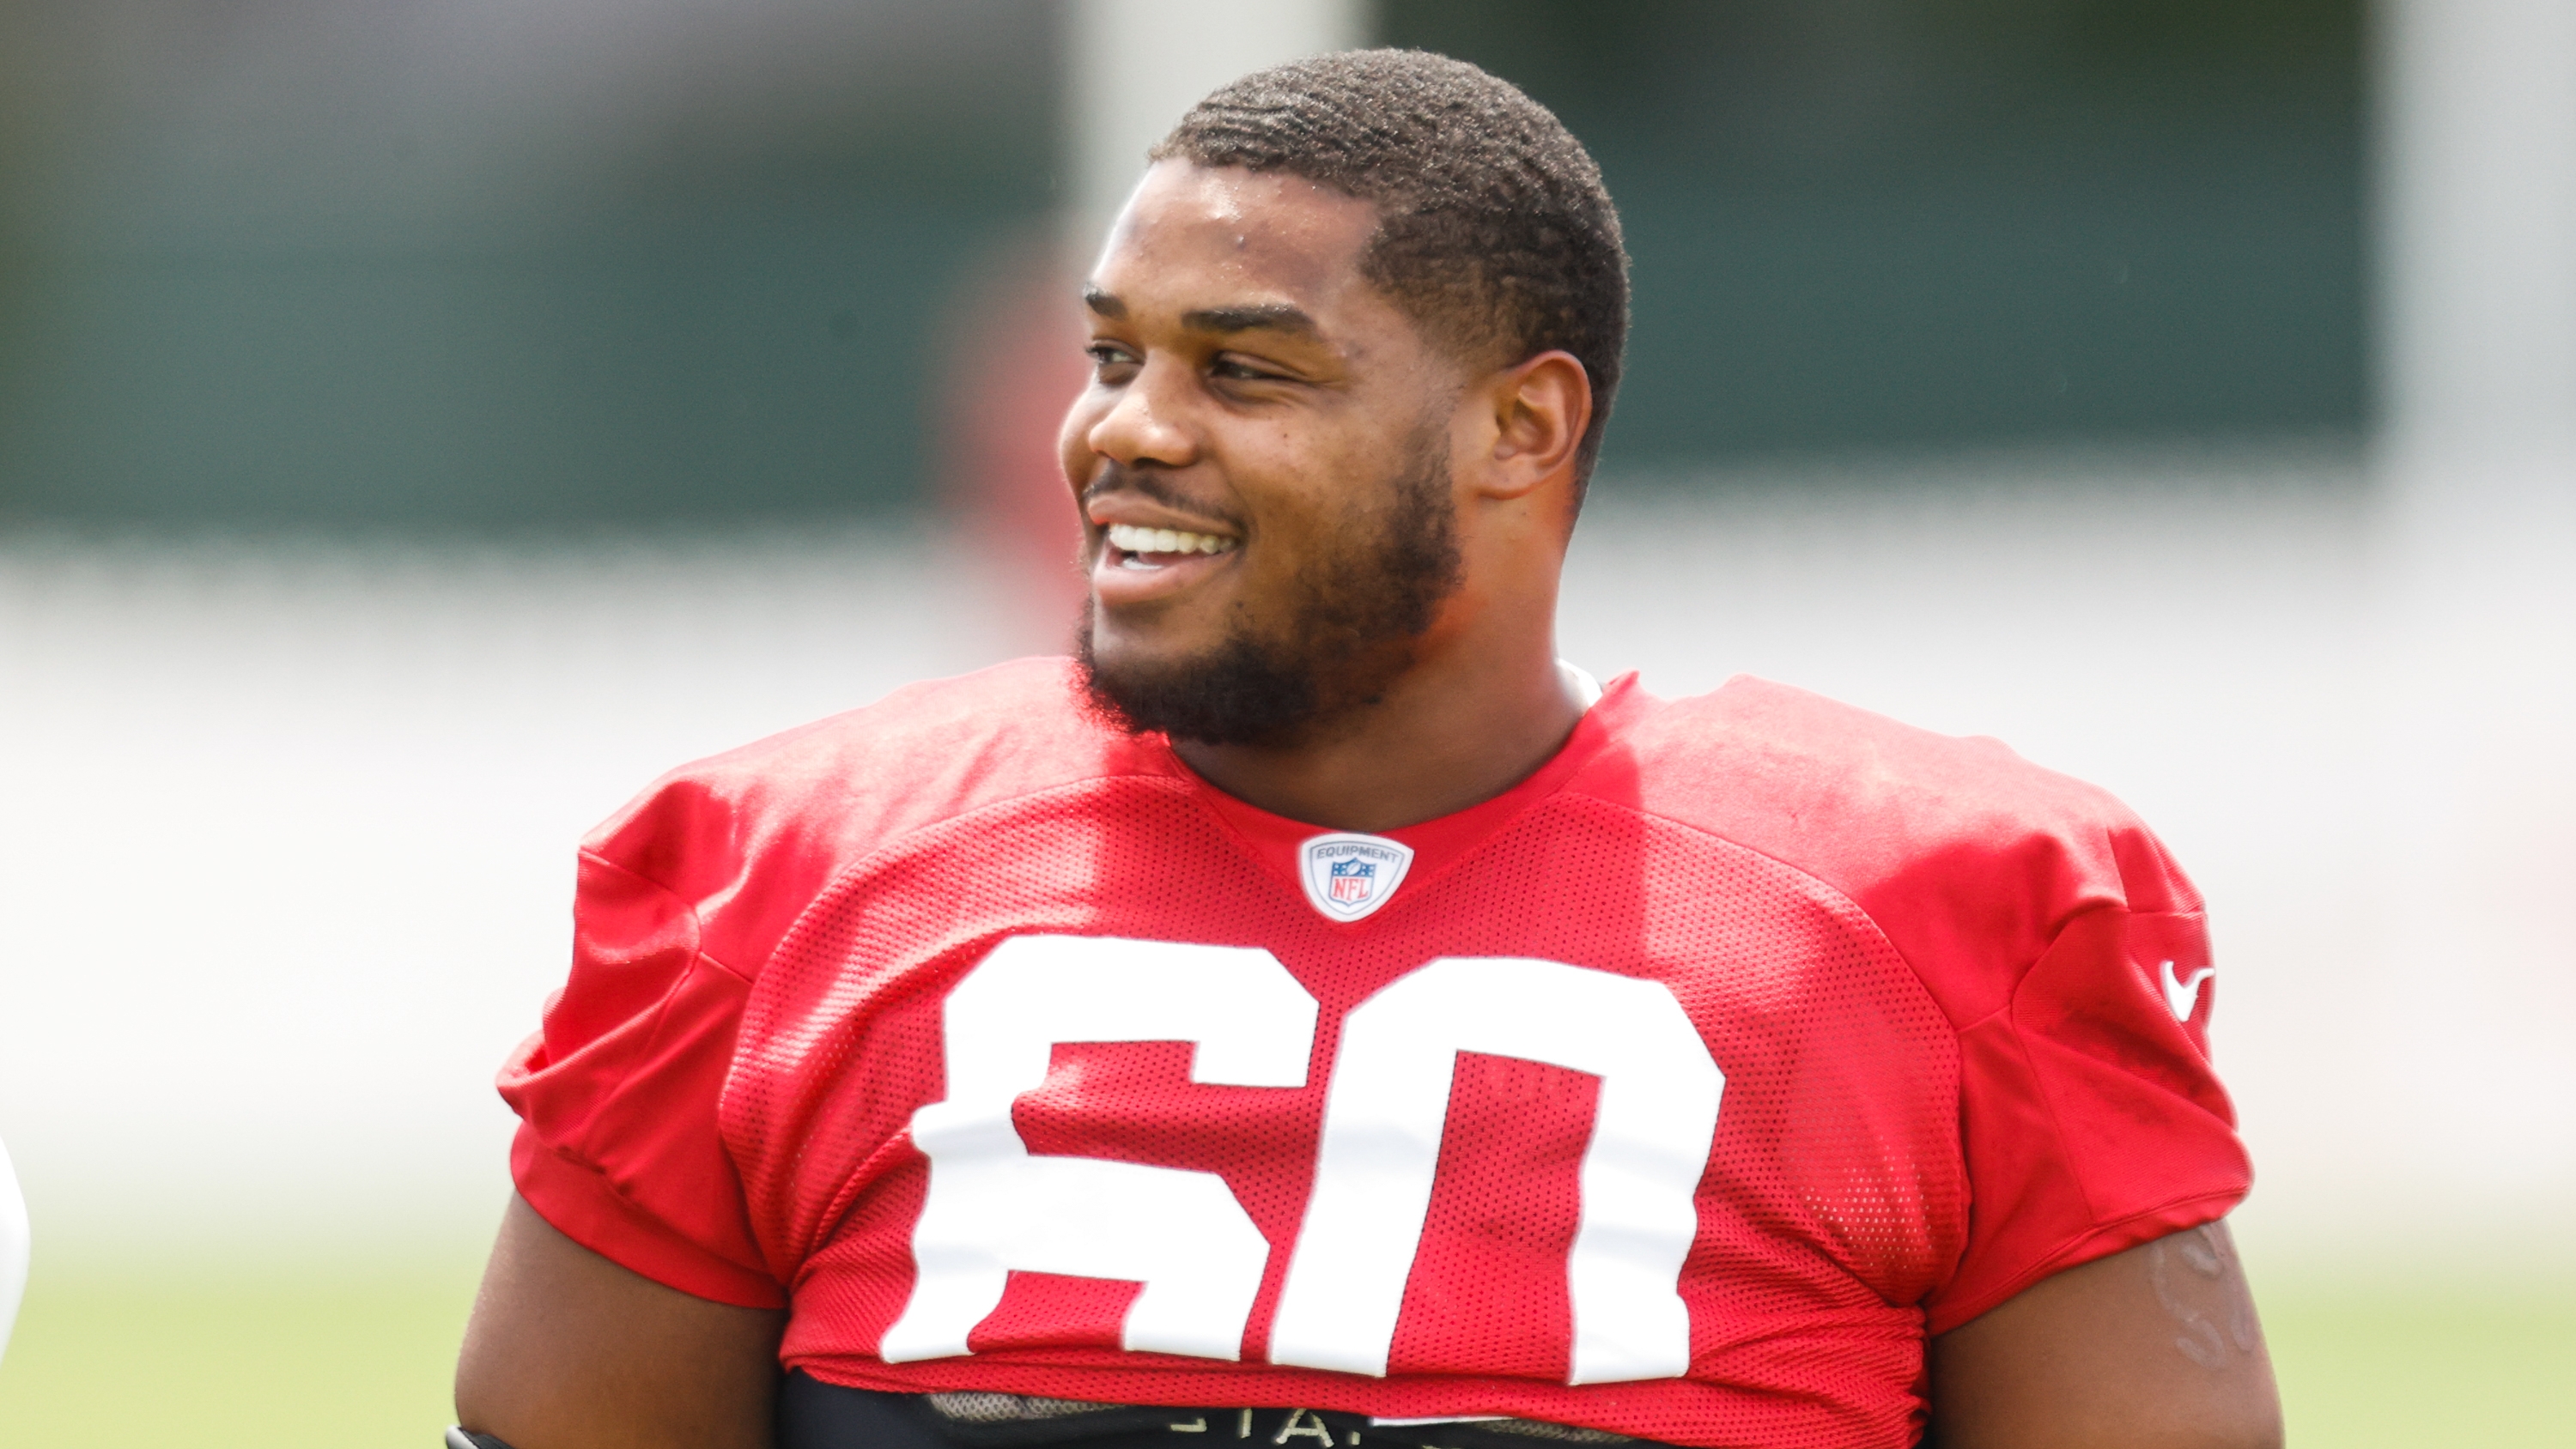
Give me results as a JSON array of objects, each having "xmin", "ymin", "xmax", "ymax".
[{"xmin": 456, "ymin": 52, "xmax": 2280, "ymax": 1449}]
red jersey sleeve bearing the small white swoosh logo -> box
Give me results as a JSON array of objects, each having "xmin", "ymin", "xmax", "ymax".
[{"xmin": 1927, "ymin": 900, "xmax": 2251, "ymax": 1333}]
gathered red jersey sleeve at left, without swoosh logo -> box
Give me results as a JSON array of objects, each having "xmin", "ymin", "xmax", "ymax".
[{"xmin": 500, "ymin": 849, "xmax": 786, "ymax": 1307}]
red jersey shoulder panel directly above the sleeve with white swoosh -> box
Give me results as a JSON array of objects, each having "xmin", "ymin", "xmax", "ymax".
[{"xmin": 1631, "ymin": 677, "xmax": 2200, "ymax": 1016}]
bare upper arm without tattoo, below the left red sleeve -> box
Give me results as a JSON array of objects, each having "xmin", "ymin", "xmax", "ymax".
[{"xmin": 456, "ymin": 1197, "xmax": 786, "ymax": 1449}]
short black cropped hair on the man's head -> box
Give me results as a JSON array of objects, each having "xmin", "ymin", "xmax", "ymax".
[{"xmin": 1151, "ymin": 49, "xmax": 1628, "ymax": 497}]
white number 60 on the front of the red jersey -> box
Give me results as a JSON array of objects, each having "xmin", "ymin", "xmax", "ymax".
[{"xmin": 878, "ymin": 937, "xmax": 1726, "ymax": 1385}]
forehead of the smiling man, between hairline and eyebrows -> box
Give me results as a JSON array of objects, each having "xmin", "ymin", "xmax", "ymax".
[{"xmin": 1092, "ymin": 160, "xmax": 1378, "ymax": 312}]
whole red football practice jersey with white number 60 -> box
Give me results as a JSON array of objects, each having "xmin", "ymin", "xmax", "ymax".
[{"xmin": 502, "ymin": 662, "xmax": 2249, "ymax": 1446}]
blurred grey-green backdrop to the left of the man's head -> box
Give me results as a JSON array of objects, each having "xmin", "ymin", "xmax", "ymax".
[{"xmin": 0, "ymin": 0, "xmax": 1056, "ymax": 530}]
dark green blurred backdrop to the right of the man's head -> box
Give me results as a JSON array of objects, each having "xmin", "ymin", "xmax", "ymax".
[{"xmin": 1386, "ymin": 0, "xmax": 2365, "ymax": 471}]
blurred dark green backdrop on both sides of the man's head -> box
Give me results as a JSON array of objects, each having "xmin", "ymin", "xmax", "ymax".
[{"xmin": 0, "ymin": 0, "xmax": 2367, "ymax": 528}]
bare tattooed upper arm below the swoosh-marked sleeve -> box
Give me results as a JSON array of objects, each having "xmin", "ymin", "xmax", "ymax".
[{"xmin": 1927, "ymin": 1222, "xmax": 2282, "ymax": 1449}]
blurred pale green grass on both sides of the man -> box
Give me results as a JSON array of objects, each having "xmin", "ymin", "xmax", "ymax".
[{"xmin": 0, "ymin": 1256, "xmax": 2576, "ymax": 1449}]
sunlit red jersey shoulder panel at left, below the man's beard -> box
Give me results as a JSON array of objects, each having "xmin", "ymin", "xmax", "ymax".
[{"xmin": 582, "ymin": 659, "xmax": 1154, "ymax": 970}]
